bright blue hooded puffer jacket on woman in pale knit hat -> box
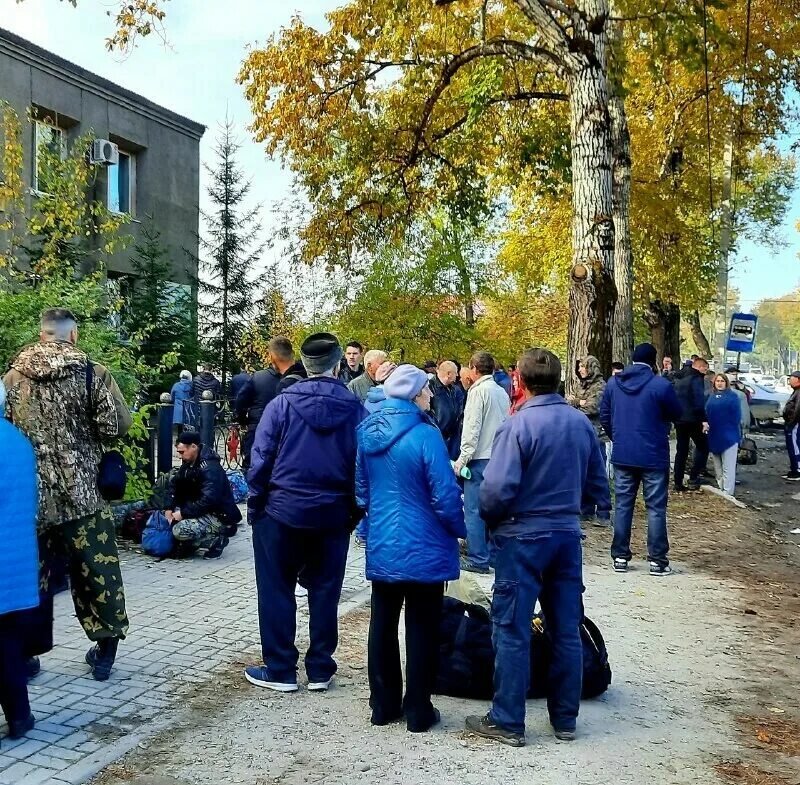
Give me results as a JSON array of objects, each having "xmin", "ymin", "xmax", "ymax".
[{"xmin": 356, "ymin": 398, "xmax": 467, "ymax": 583}]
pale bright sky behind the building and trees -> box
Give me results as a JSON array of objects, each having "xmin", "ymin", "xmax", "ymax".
[{"xmin": 0, "ymin": 0, "xmax": 800, "ymax": 310}]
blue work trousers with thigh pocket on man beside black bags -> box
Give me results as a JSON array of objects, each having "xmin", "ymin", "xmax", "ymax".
[{"xmin": 489, "ymin": 531, "xmax": 583, "ymax": 733}]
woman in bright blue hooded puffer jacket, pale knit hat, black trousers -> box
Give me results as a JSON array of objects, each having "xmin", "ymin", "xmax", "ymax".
[{"xmin": 356, "ymin": 365, "xmax": 466, "ymax": 732}]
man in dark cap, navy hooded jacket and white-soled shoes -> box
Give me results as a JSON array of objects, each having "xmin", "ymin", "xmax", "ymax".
[{"xmin": 245, "ymin": 333, "xmax": 366, "ymax": 692}]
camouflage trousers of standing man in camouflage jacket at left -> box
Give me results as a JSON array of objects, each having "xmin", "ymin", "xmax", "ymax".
[{"xmin": 39, "ymin": 507, "xmax": 128, "ymax": 641}]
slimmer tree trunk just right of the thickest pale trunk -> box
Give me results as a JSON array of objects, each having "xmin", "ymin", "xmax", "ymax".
[{"xmin": 608, "ymin": 16, "xmax": 633, "ymax": 364}]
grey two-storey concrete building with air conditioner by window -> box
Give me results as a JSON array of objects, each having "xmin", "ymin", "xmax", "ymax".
[{"xmin": 0, "ymin": 28, "xmax": 205, "ymax": 286}]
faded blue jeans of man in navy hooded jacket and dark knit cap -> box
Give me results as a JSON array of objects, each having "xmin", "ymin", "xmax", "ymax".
[{"xmin": 611, "ymin": 466, "xmax": 669, "ymax": 567}]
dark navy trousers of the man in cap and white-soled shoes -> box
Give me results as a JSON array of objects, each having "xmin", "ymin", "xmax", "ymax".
[{"xmin": 253, "ymin": 516, "xmax": 350, "ymax": 683}]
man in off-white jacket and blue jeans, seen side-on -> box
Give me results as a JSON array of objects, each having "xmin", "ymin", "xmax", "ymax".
[{"xmin": 455, "ymin": 352, "xmax": 509, "ymax": 574}]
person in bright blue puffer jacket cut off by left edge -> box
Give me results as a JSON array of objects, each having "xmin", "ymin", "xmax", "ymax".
[{"xmin": 0, "ymin": 382, "xmax": 39, "ymax": 739}]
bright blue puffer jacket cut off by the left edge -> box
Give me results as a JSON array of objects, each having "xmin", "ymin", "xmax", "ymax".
[{"xmin": 0, "ymin": 419, "xmax": 39, "ymax": 614}]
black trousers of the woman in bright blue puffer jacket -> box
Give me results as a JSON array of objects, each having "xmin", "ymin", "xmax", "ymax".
[{"xmin": 368, "ymin": 581, "xmax": 444, "ymax": 731}]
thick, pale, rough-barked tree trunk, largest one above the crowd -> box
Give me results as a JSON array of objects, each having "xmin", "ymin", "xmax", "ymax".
[{"xmin": 566, "ymin": 7, "xmax": 616, "ymax": 392}]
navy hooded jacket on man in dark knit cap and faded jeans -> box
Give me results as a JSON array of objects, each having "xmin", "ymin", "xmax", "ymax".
[{"xmin": 600, "ymin": 363, "xmax": 682, "ymax": 471}]
